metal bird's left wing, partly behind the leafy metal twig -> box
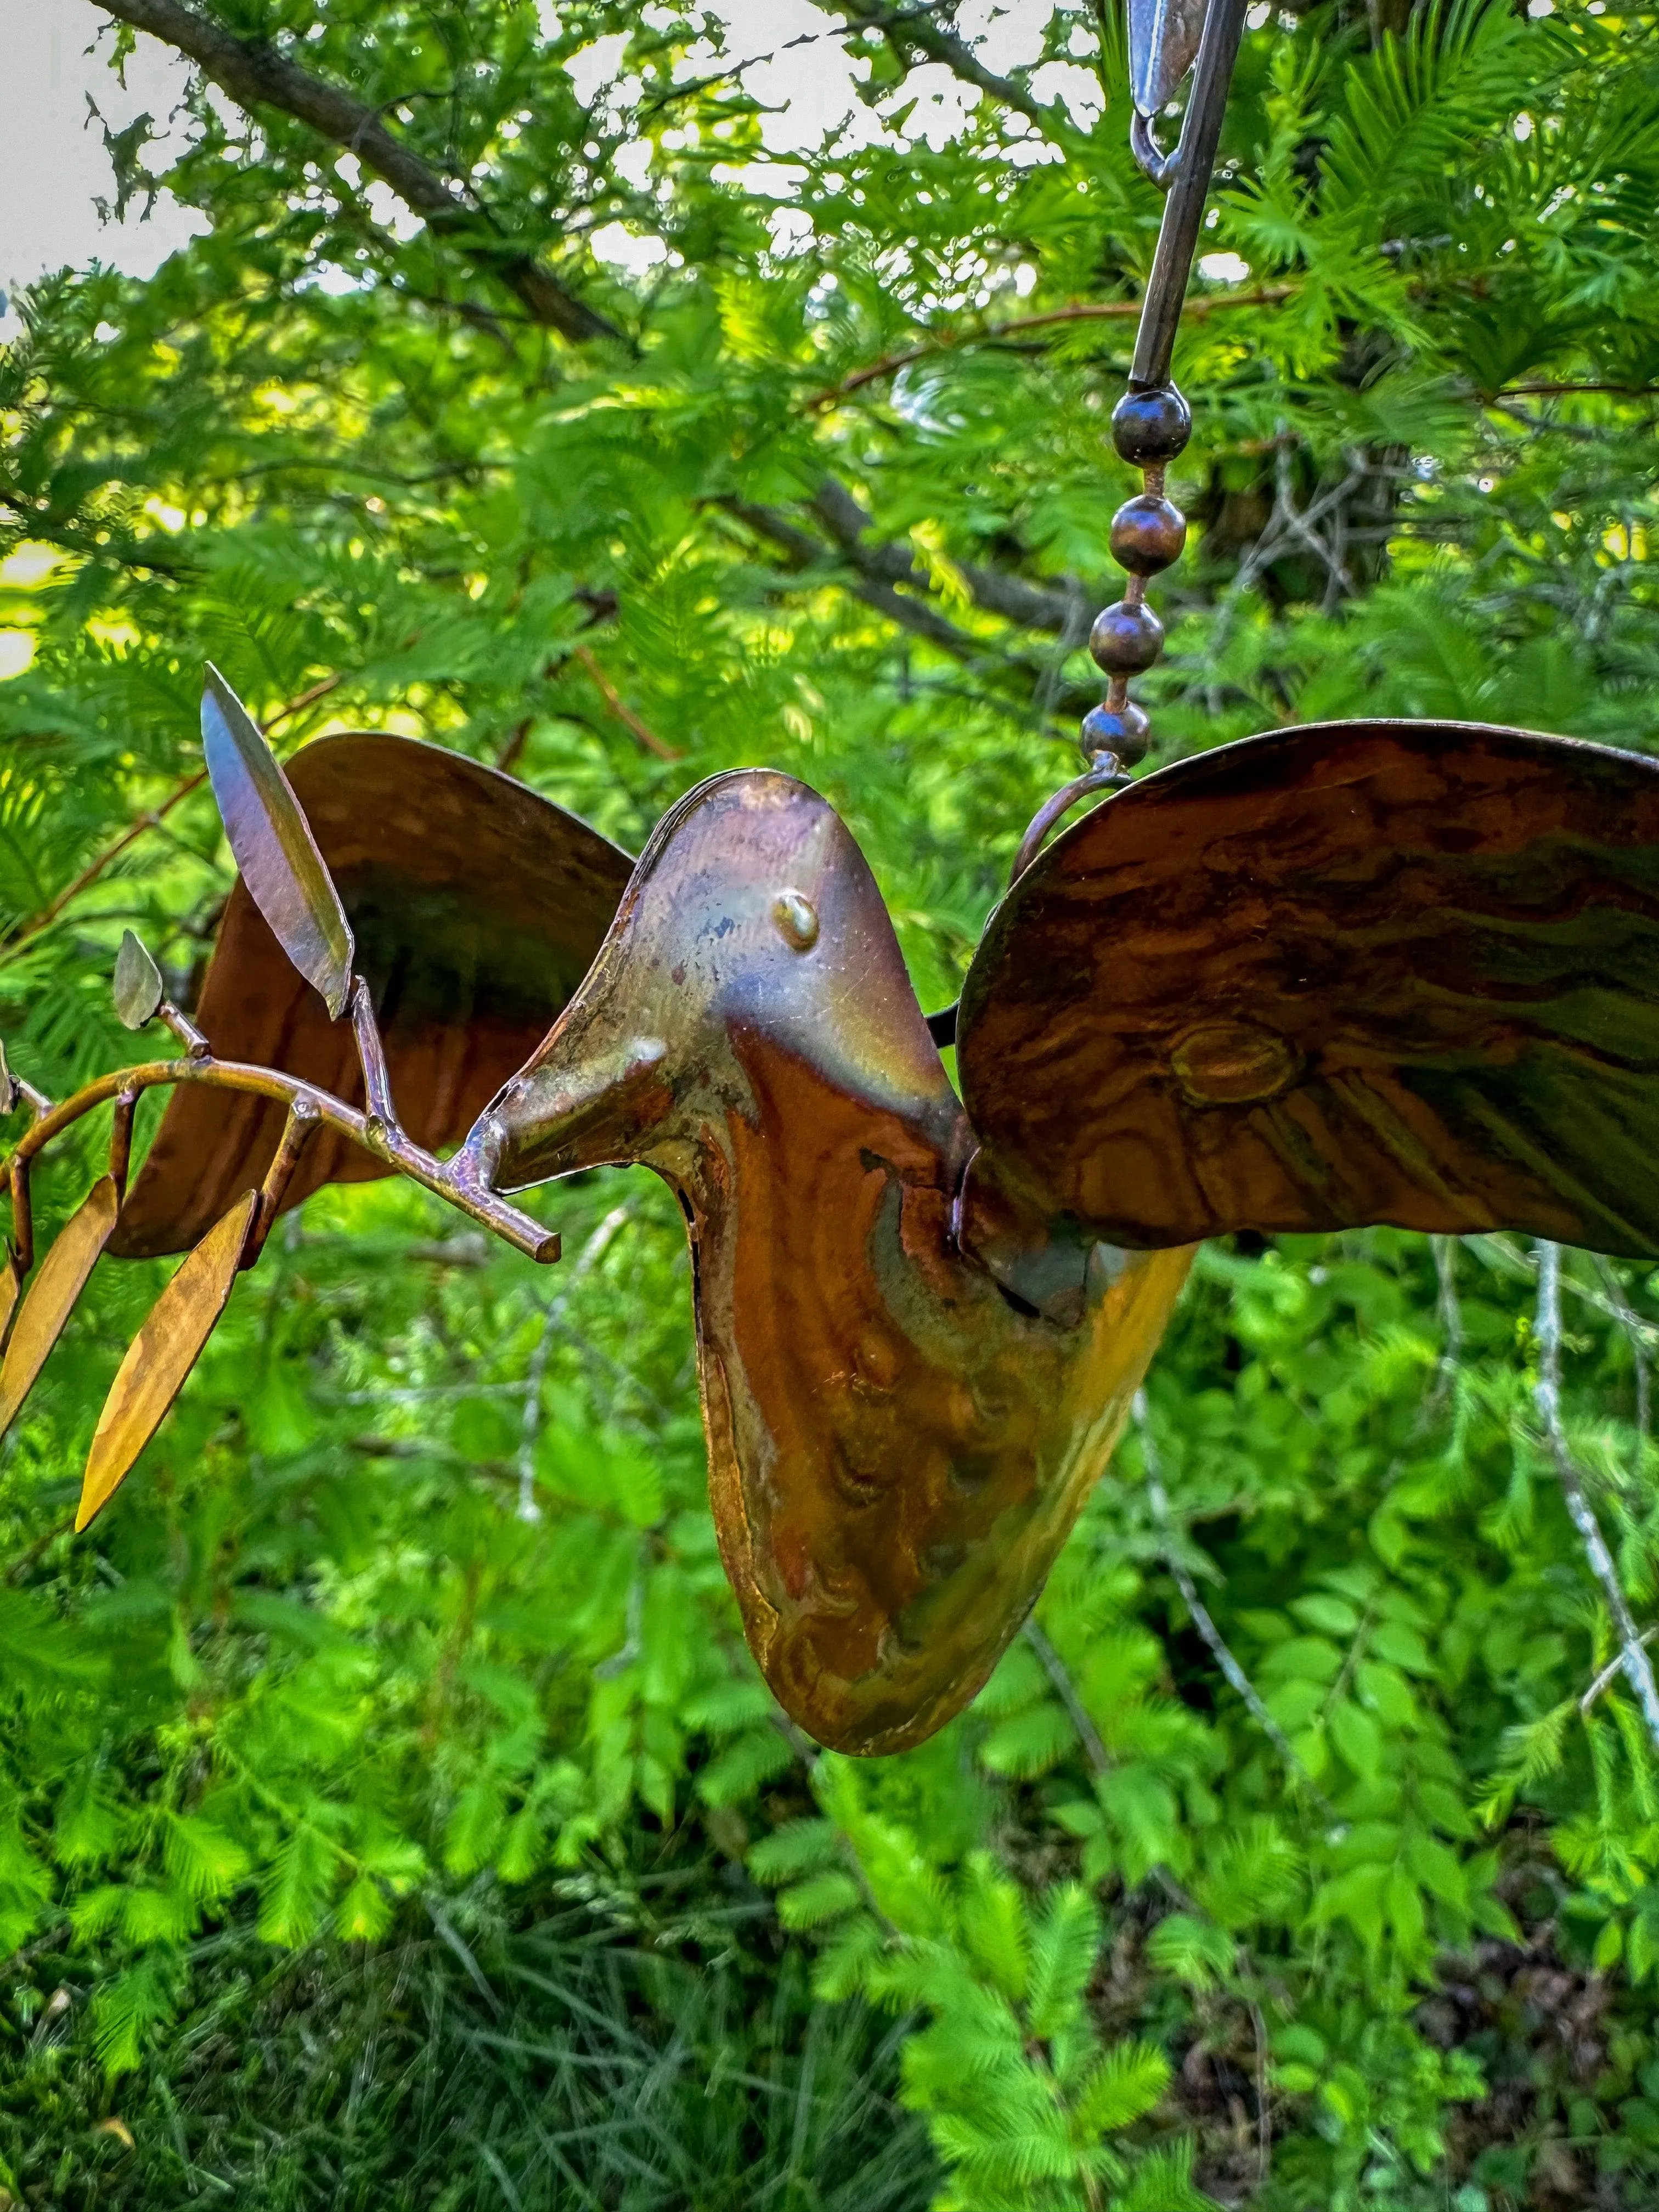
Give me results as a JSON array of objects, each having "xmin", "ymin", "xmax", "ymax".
[{"xmin": 111, "ymin": 732, "xmax": 633, "ymax": 1259}]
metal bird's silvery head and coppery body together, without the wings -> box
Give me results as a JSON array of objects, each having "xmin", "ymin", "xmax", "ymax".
[{"xmin": 469, "ymin": 770, "xmax": 1188, "ymax": 1752}]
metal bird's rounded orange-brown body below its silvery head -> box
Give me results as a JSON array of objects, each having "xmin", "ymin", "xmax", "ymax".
[{"xmin": 663, "ymin": 1013, "xmax": 1186, "ymax": 1752}]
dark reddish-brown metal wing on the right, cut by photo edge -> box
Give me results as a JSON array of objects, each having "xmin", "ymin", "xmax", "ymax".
[{"xmin": 958, "ymin": 721, "xmax": 1659, "ymax": 1254}]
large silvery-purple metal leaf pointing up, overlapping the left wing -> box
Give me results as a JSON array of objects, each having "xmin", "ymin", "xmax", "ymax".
[{"xmin": 201, "ymin": 662, "xmax": 356, "ymax": 1022}]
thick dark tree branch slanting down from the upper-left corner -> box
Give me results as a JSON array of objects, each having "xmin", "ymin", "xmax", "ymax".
[{"xmin": 93, "ymin": 0, "xmax": 622, "ymax": 343}]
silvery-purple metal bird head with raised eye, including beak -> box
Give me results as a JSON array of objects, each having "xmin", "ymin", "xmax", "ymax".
[{"xmin": 462, "ymin": 770, "xmax": 949, "ymax": 1190}]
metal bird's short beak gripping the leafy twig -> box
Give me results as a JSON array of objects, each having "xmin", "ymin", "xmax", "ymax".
[{"xmin": 452, "ymin": 1020, "xmax": 673, "ymax": 1190}]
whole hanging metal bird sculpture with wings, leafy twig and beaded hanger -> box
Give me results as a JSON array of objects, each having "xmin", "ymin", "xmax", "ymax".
[{"xmin": 0, "ymin": 0, "xmax": 1659, "ymax": 1752}]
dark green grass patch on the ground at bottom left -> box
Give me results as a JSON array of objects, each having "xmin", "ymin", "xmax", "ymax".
[{"xmin": 0, "ymin": 1898, "xmax": 938, "ymax": 2212}]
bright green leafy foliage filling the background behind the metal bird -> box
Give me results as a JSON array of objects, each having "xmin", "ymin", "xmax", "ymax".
[{"xmin": 0, "ymin": 0, "xmax": 1659, "ymax": 2212}]
